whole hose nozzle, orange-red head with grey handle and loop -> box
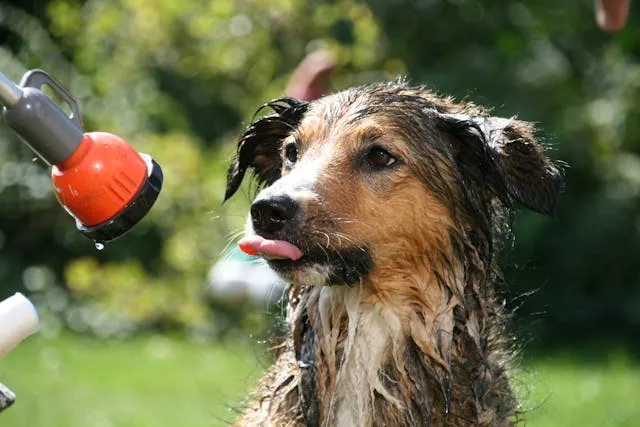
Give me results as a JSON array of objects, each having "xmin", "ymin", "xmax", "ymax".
[{"xmin": 0, "ymin": 70, "xmax": 163, "ymax": 242}]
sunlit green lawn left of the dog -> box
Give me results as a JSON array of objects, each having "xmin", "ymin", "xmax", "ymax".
[{"xmin": 0, "ymin": 336, "xmax": 264, "ymax": 427}]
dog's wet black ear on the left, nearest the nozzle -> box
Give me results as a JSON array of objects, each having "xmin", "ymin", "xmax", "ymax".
[{"xmin": 224, "ymin": 98, "xmax": 308, "ymax": 201}]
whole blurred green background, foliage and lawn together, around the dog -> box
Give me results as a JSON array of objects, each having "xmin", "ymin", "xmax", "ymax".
[{"xmin": 0, "ymin": 0, "xmax": 640, "ymax": 427}]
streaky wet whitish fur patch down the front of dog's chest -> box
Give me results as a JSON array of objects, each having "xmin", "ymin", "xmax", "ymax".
[{"xmin": 290, "ymin": 286, "xmax": 390, "ymax": 426}]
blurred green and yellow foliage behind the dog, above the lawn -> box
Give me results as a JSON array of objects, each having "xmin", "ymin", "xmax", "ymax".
[{"xmin": 0, "ymin": 0, "xmax": 640, "ymax": 345}]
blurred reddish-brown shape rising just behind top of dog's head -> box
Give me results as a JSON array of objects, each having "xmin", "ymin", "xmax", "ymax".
[{"xmin": 284, "ymin": 50, "xmax": 336, "ymax": 101}]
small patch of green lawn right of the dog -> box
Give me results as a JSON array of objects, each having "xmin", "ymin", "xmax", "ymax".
[{"xmin": 517, "ymin": 352, "xmax": 640, "ymax": 427}]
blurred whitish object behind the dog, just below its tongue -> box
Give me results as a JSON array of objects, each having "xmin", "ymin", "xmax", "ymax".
[{"xmin": 207, "ymin": 246, "xmax": 284, "ymax": 305}]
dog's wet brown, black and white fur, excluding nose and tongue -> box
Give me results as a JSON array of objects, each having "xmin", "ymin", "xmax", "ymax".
[{"xmin": 226, "ymin": 81, "xmax": 562, "ymax": 426}]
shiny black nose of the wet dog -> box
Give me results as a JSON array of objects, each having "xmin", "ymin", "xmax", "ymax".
[{"xmin": 251, "ymin": 196, "xmax": 298, "ymax": 234}]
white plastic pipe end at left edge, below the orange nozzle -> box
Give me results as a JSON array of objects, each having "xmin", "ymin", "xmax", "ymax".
[{"xmin": 0, "ymin": 292, "xmax": 40, "ymax": 358}]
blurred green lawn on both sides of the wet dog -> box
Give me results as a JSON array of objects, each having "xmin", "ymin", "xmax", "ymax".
[{"xmin": 0, "ymin": 335, "xmax": 640, "ymax": 427}]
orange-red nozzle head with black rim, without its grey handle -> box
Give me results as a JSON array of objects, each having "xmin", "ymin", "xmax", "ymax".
[{"xmin": 51, "ymin": 132, "xmax": 162, "ymax": 242}]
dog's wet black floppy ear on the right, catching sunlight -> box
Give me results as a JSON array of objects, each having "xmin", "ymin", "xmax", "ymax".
[{"xmin": 439, "ymin": 114, "xmax": 563, "ymax": 214}]
